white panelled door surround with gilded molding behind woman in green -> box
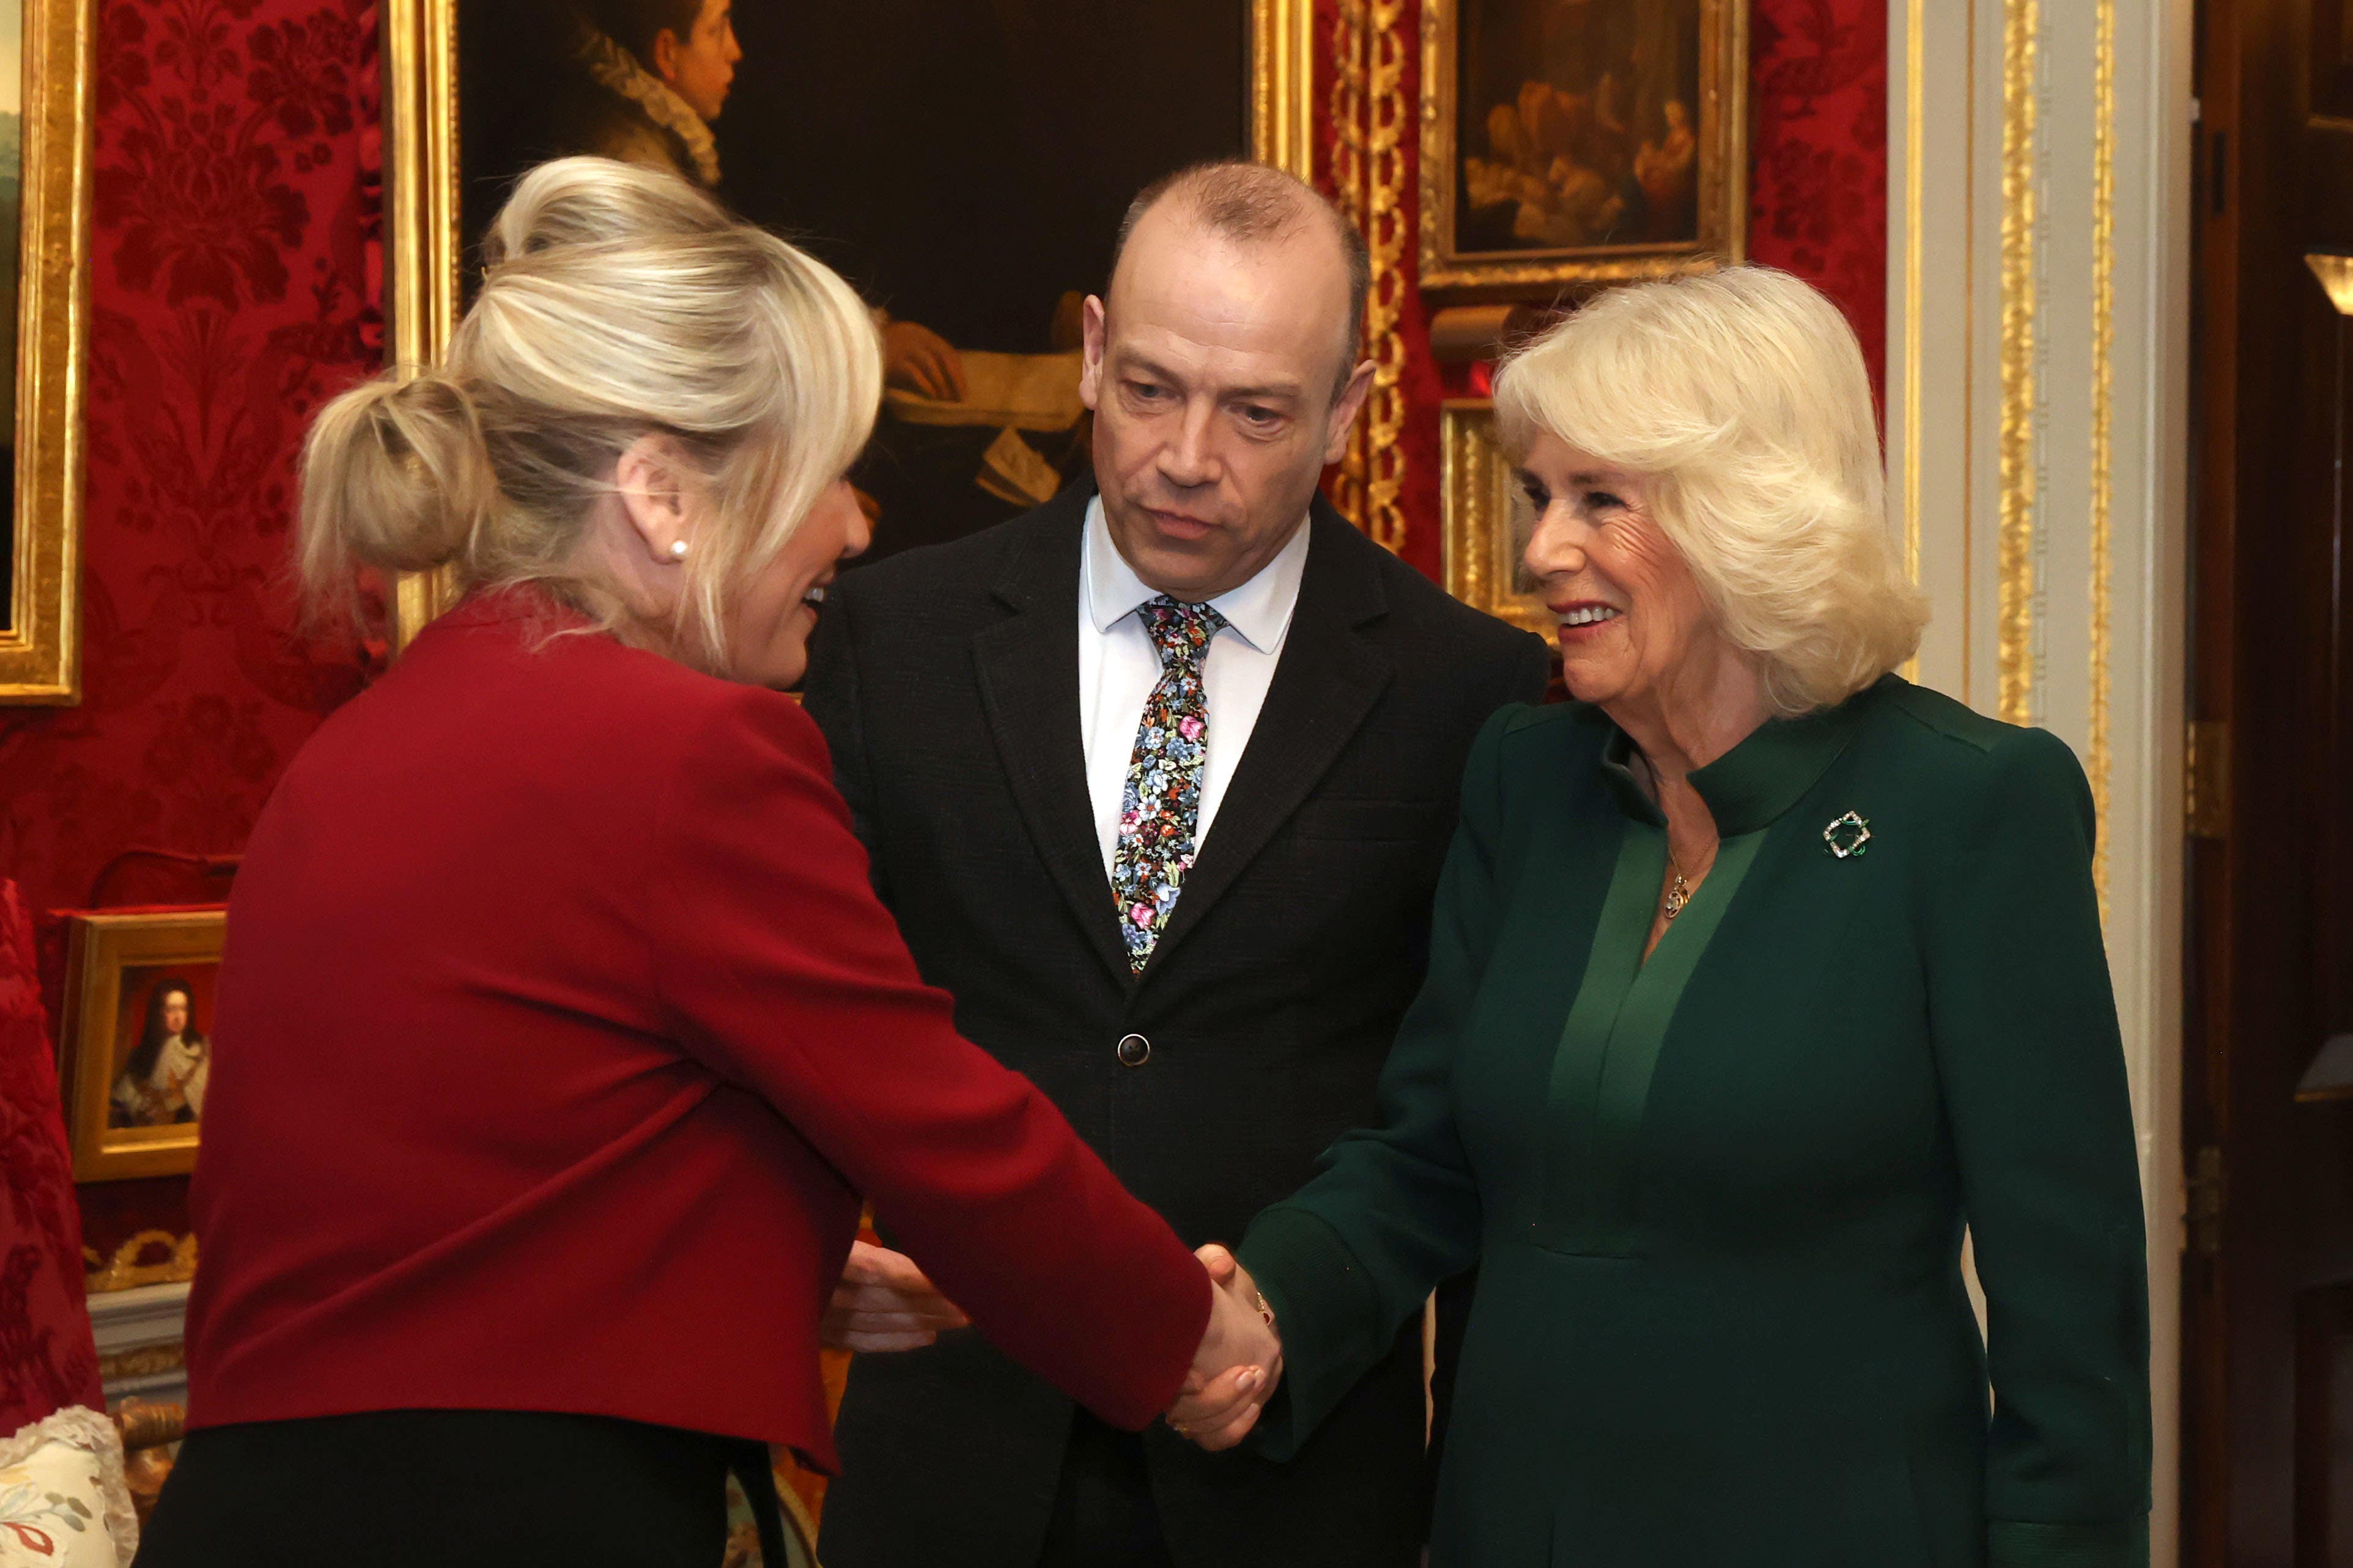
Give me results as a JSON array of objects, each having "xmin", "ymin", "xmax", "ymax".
[{"xmin": 1887, "ymin": 0, "xmax": 2190, "ymax": 1568}]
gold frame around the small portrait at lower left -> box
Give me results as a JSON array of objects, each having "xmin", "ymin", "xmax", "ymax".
[{"xmin": 56, "ymin": 910, "xmax": 228, "ymax": 1182}]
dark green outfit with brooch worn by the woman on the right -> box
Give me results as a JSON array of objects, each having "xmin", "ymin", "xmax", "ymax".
[{"xmin": 1238, "ymin": 677, "xmax": 2148, "ymax": 1568}]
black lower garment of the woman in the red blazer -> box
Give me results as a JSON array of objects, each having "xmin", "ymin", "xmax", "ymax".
[{"xmin": 136, "ymin": 1410, "xmax": 783, "ymax": 1568}]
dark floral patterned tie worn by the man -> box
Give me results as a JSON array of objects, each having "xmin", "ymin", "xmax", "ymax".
[{"xmin": 1110, "ymin": 595, "xmax": 1226, "ymax": 971}]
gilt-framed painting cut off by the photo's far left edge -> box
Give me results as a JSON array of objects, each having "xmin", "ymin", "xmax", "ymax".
[{"xmin": 0, "ymin": 0, "xmax": 94, "ymax": 703}]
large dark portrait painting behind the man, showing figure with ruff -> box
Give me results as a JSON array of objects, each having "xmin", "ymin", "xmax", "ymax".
[{"xmin": 393, "ymin": 0, "xmax": 1306, "ymax": 576}]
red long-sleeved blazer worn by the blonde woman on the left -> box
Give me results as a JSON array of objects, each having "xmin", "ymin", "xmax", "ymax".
[{"xmin": 188, "ymin": 595, "xmax": 1210, "ymax": 1469}]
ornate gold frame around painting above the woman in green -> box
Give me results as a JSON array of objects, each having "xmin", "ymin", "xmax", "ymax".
[{"xmin": 1421, "ymin": 0, "xmax": 1748, "ymax": 298}]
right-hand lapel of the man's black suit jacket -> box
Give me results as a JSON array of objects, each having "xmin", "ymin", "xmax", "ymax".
[{"xmin": 1143, "ymin": 496, "xmax": 1395, "ymax": 981}]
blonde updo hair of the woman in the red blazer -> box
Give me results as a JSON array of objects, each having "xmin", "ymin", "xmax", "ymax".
[{"xmin": 299, "ymin": 158, "xmax": 882, "ymax": 672}]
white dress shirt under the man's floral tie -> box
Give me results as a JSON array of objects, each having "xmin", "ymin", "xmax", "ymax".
[{"xmin": 1077, "ymin": 496, "xmax": 1310, "ymax": 877}]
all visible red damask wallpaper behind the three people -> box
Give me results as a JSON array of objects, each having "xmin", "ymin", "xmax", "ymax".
[{"xmin": 0, "ymin": 0, "xmax": 1887, "ymax": 1248}]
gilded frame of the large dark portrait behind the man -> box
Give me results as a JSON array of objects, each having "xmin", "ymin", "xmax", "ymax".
[{"xmin": 376, "ymin": 0, "xmax": 1315, "ymax": 649}]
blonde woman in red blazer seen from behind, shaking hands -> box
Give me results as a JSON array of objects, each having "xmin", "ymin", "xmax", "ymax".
[{"xmin": 141, "ymin": 160, "xmax": 1271, "ymax": 1568}]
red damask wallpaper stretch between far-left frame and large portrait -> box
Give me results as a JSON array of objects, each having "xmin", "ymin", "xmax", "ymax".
[{"xmin": 0, "ymin": 0, "xmax": 381, "ymax": 910}]
